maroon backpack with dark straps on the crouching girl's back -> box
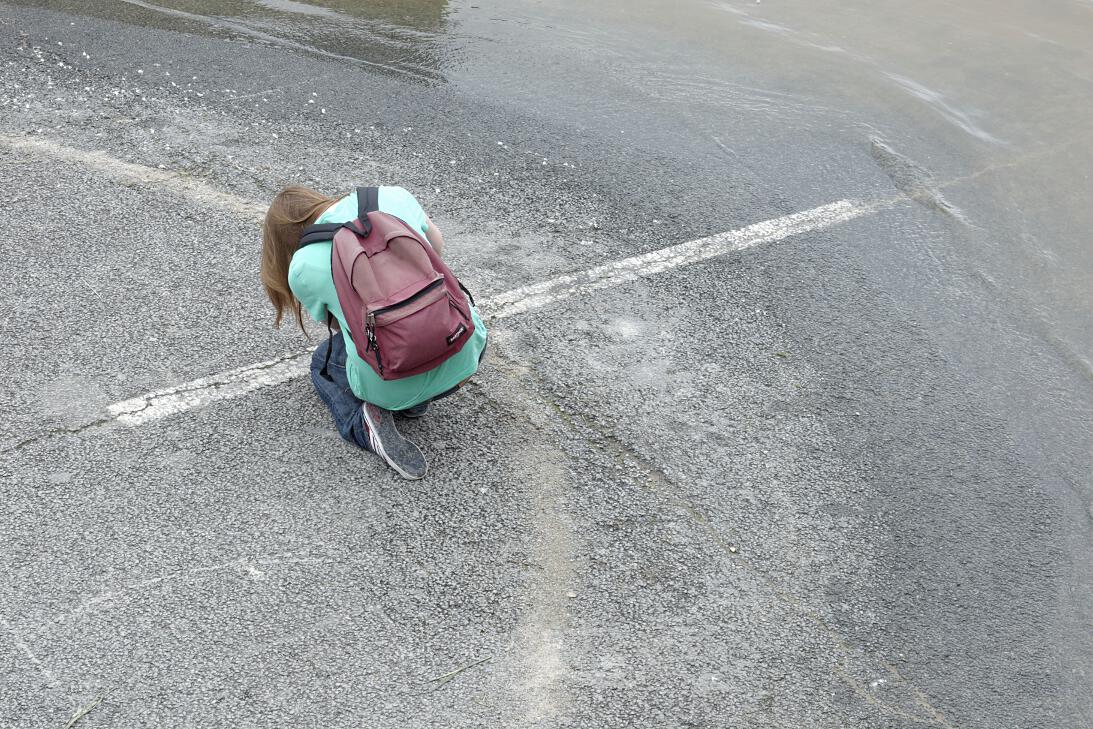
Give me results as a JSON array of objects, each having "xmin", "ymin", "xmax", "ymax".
[{"xmin": 299, "ymin": 187, "xmax": 474, "ymax": 379}]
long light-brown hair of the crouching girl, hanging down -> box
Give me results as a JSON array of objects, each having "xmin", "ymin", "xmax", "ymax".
[{"xmin": 261, "ymin": 186, "xmax": 337, "ymax": 334}]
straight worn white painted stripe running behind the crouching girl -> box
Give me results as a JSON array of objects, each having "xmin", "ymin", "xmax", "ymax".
[{"xmin": 108, "ymin": 200, "xmax": 877, "ymax": 425}]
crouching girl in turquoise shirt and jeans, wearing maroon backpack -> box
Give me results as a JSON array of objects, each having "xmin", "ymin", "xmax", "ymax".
[{"xmin": 261, "ymin": 187, "xmax": 486, "ymax": 479}]
